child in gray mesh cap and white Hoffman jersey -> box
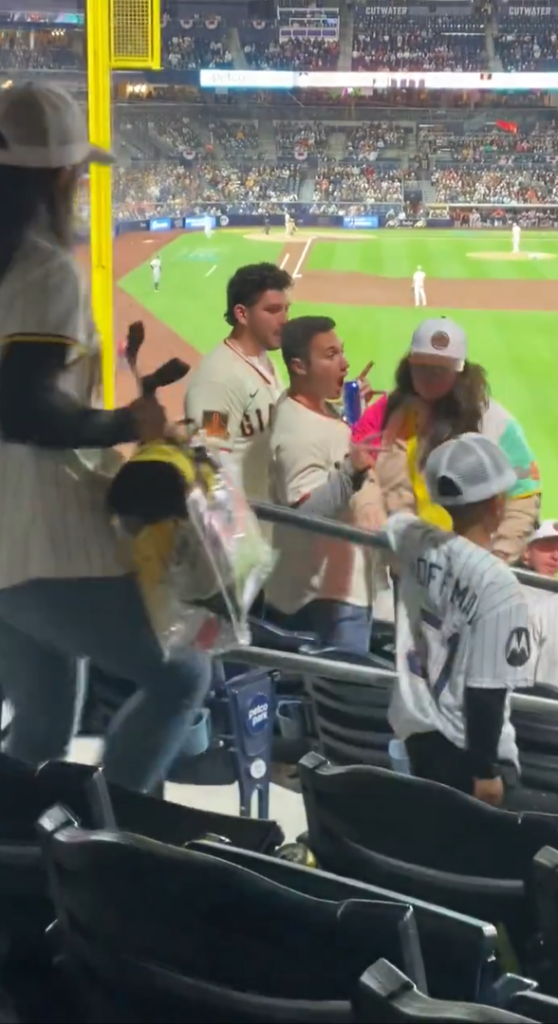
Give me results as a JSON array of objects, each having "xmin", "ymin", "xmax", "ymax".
[{"xmin": 386, "ymin": 434, "xmax": 532, "ymax": 806}]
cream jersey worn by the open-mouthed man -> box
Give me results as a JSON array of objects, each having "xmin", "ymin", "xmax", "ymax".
[{"xmin": 265, "ymin": 394, "xmax": 374, "ymax": 614}]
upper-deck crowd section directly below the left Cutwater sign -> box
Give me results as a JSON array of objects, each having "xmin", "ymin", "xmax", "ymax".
[{"xmin": 352, "ymin": 14, "xmax": 487, "ymax": 71}]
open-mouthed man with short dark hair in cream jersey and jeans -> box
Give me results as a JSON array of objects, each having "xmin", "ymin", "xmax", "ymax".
[{"xmin": 265, "ymin": 316, "xmax": 374, "ymax": 651}]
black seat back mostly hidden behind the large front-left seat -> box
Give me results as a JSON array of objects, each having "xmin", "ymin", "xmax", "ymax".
[{"xmin": 188, "ymin": 841, "xmax": 497, "ymax": 1002}]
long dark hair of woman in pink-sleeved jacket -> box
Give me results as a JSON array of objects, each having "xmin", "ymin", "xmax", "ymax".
[{"xmin": 383, "ymin": 355, "xmax": 490, "ymax": 462}]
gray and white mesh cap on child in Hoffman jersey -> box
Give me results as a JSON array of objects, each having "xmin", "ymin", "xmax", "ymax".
[{"xmin": 425, "ymin": 433, "xmax": 517, "ymax": 508}]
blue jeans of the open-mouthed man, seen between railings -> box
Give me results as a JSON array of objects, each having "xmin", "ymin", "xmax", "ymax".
[{"xmin": 266, "ymin": 598, "xmax": 372, "ymax": 654}]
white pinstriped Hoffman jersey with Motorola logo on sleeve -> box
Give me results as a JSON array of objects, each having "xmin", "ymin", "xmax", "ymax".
[{"xmin": 386, "ymin": 513, "xmax": 532, "ymax": 763}]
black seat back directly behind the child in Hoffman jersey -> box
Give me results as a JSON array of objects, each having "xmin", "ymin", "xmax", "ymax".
[{"xmin": 299, "ymin": 754, "xmax": 558, "ymax": 966}]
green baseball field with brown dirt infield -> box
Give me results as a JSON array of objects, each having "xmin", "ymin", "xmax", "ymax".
[{"xmin": 115, "ymin": 229, "xmax": 558, "ymax": 507}]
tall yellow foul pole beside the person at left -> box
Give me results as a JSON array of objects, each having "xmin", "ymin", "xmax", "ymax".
[{"xmin": 86, "ymin": 0, "xmax": 116, "ymax": 409}]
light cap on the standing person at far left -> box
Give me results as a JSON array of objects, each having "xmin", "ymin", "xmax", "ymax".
[{"xmin": 0, "ymin": 82, "xmax": 115, "ymax": 169}]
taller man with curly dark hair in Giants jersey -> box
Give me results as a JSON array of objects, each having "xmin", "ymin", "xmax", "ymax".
[{"xmin": 185, "ymin": 263, "xmax": 293, "ymax": 501}]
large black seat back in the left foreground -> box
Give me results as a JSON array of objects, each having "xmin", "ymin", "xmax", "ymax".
[{"xmin": 41, "ymin": 808, "xmax": 422, "ymax": 1024}]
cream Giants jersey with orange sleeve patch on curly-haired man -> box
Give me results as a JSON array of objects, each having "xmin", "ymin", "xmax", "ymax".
[{"xmin": 185, "ymin": 341, "xmax": 282, "ymax": 501}]
